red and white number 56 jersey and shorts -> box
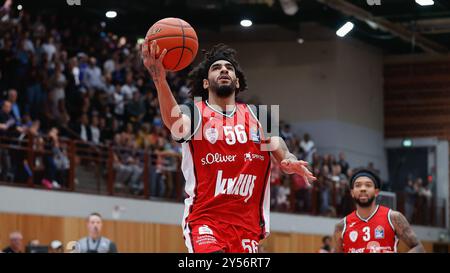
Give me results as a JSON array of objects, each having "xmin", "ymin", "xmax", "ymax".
[{"xmin": 181, "ymin": 101, "xmax": 270, "ymax": 252}]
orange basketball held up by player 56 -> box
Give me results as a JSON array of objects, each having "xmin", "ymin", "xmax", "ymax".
[{"xmin": 146, "ymin": 18, "xmax": 198, "ymax": 71}]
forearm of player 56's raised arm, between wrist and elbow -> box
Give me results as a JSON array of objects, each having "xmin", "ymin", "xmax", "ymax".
[{"xmin": 155, "ymin": 79, "xmax": 181, "ymax": 129}]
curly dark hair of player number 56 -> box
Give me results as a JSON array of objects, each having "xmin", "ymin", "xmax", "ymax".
[{"xmin": 188, "ymin": 44, "xmax": 247, "ymax": 100}]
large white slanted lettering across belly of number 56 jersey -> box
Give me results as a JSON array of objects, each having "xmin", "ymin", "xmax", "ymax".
[{"xmin": 214, "ymin": 171, "xmax": 256, "ymax": 202}]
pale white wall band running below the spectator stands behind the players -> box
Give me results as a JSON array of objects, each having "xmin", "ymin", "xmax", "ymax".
[{"xmin": 0, "ymin": 186, "xmax": 443, "ymax": 241}]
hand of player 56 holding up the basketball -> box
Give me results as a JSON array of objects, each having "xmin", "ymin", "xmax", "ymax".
[{"xmin": 141, "ymin": 38, "xmax": 167, "ymax": 81}]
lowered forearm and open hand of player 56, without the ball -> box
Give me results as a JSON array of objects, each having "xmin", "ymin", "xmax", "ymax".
[{"xmin": 270, "ymin": 136, "xmax": 317, "ymax": 183}]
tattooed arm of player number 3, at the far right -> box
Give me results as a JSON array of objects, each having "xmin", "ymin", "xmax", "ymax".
[{"xmin": 391, "ymin": 211, "xmax": 425, "ymax": 253}]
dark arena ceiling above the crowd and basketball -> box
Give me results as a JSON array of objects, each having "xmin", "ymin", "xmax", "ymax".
[{"xmin": 15, "ymin": 0, "xmax": 450, "ymax": 54}]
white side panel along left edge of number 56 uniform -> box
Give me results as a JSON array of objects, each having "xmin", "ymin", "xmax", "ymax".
[{"xmin": 181, "ymin": 143, "xmax": 197, "ymax": 253}]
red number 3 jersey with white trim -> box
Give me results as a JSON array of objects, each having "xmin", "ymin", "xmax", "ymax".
[{"xmin": 342, "ymin": 205, "xmax": 398, "ymax": 253}]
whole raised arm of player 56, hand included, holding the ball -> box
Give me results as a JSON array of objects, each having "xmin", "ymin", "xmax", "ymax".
[{"xmin": 142, "ymin": 39, "xmax": 191, "ymax": 138}]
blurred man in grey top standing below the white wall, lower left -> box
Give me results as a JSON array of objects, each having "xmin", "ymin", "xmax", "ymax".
[{"xmin": 77, "ymin": 212, "xmax": 117, "ymax": 253}]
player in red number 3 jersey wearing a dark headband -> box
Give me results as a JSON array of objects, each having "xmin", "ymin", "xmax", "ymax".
[{"xmin": 334, "ymin": 170, "xmax": 425, "ymax": 253}]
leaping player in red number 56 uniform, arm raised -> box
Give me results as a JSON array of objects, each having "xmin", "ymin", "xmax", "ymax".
[{"xmin": 142, "ymin": 41, "xmax": 315, "ymax": 253}]
